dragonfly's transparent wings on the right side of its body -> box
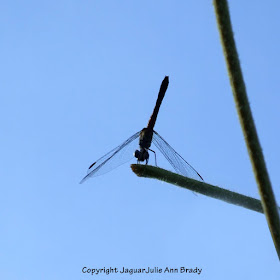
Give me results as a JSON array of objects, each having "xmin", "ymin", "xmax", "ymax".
[{"xmin": 152, "ymin": 131, "xmax": 203, "ymax": 181}]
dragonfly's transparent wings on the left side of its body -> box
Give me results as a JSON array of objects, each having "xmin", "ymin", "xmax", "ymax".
[{"xmin": 80, "ymin": 131, "xmax": 141, "ymax": 184}]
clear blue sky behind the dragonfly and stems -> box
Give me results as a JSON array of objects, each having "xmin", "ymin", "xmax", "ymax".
[{"xmin": 0, "ymin": 0, "xmax": 280, "ymax": 280}]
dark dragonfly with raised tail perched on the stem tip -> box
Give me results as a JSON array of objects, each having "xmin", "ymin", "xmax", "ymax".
[{"xmin": 80, "ymin": 76, "xmax": 203, "ymax": 184}]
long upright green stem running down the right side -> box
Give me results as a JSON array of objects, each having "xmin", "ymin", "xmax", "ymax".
[{"xmin": 213, "ymin": 0, "xmax": 280, "ymax": 259}]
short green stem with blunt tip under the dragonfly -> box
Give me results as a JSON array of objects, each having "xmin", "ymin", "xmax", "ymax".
[{"xmin": 131, "ymin": 164, "xmax": 280, "ymax": 213}]
